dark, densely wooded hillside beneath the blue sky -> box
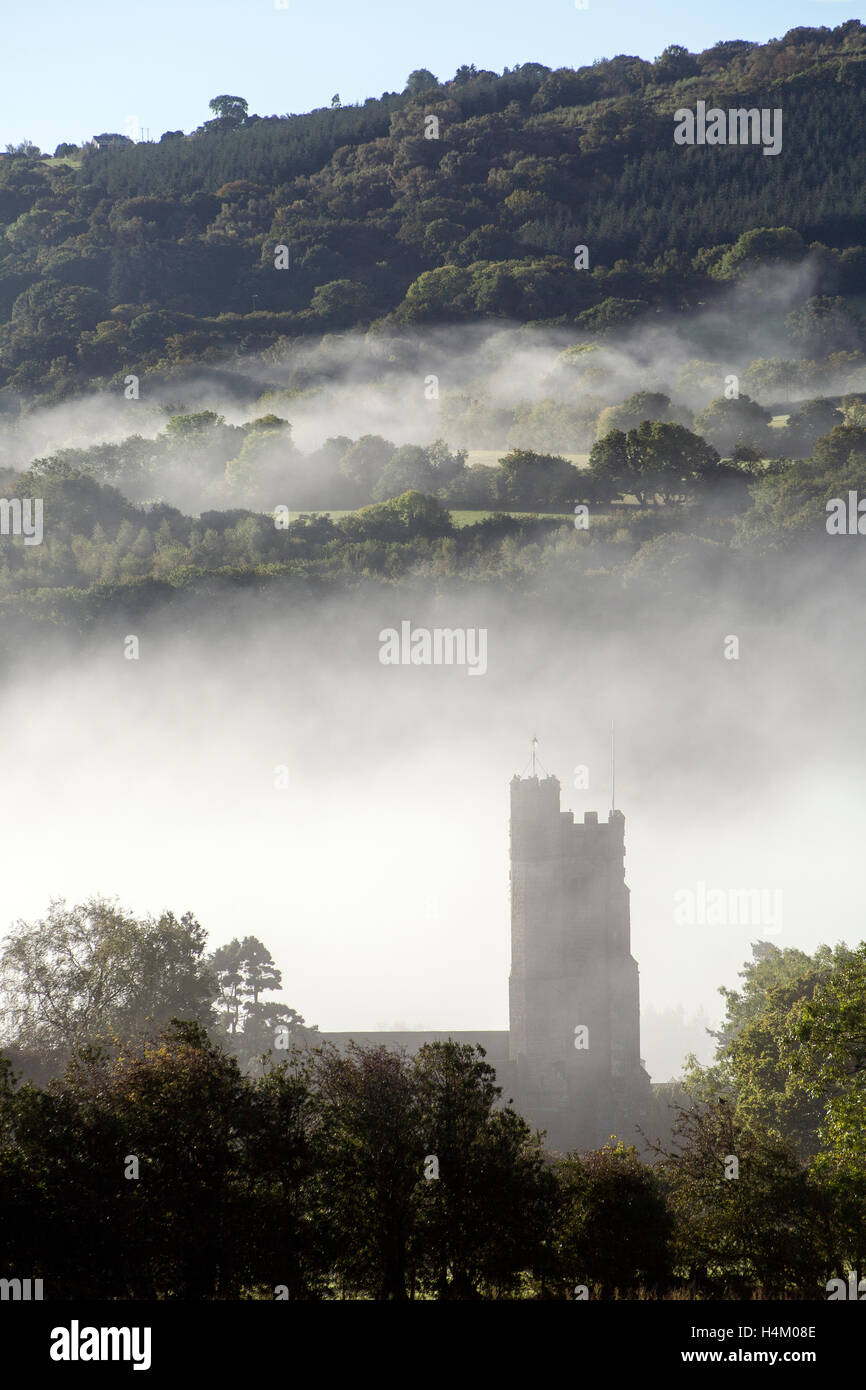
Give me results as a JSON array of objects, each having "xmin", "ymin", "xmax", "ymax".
[{"xmin": 0, "ymin": 19, "xmax": 866, "ymax": 410}]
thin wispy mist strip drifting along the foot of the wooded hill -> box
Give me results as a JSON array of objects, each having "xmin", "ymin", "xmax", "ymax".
[{"xmin": 0, "ymin": 257, "xmax": 866, "ymax": 514}]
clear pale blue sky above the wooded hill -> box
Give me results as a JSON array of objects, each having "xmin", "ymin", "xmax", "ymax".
[{"xmin": 0, "ymin": 0, "xmax": 863, "ymax": 152}]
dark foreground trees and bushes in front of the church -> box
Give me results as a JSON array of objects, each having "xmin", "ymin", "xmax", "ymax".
[{"xmin": 0, "ymin": 899, "xmax": 866, "ymax": 1301}]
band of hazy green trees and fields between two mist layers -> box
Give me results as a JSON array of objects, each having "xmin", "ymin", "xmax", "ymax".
[{"xmin": 0, "ymin": 396, "xmax": 866, "ymax": 641}]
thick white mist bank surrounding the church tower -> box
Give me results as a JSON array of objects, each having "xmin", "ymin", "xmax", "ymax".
[{"xmin": 0, "ymin": 550, "xmax": 865, "ymax": 1080}]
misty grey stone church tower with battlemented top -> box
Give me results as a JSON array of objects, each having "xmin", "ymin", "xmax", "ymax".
[{"xmin": 509, "ymin": 759, "xmax": 651, "ymax": 1151}]
